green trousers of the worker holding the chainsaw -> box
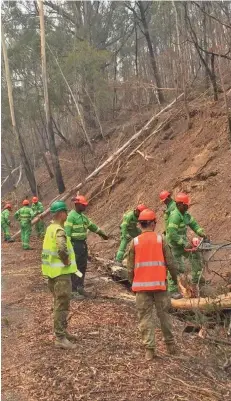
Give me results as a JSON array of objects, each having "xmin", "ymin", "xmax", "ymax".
[{"xmin": 168, "ymin": 247, "xmax": 203, "ymax": 292}]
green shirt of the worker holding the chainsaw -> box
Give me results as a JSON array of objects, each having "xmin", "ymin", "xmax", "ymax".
[{"xmin": 167, "ymin": 207, "xmax": 204, "ymax": 248}]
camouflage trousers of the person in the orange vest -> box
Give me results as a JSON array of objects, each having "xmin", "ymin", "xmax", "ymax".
[{"xmin": 136, "ymin": 291, "xmax": 174, "ymax": 349}]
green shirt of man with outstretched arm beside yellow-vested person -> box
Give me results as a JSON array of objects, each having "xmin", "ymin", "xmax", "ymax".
[{"xmin": 65, "ymin": 209, "xmax": 106, "ymax": 240}]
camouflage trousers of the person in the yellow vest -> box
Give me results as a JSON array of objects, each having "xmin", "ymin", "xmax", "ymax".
[{"xmin": 48, "ymin": 274, "xmax": 71, "ymax": 338}]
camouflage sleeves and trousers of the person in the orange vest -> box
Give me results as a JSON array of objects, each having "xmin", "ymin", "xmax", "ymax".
[{"xmin": 127, "ymin": 234, "xmax": 177, "ymax": 349}]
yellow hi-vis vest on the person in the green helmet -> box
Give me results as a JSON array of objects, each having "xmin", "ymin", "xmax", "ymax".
[{"xmin": 42, "ymin": 223, "xmax": 81, "ymax": 278}]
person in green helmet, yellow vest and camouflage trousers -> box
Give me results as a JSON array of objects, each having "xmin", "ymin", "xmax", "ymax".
[{"xmin": 42, "ymin": 201, "xmax": 81, "ymax": 349}]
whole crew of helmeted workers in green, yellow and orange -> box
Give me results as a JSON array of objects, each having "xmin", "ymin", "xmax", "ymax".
[{"xmin": 2, "ymin": 191, "xmax": 206, "ymax": 360}]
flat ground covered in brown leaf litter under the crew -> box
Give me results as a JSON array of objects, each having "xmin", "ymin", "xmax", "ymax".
[{"xmin": 2, "ymin": 238, "xmax": 231, "ymax": 401}]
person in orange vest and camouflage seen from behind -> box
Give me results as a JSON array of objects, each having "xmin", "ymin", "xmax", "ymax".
[{"xmin": 127, "ymin": 209, "xmax": 177, "ymax": 361}]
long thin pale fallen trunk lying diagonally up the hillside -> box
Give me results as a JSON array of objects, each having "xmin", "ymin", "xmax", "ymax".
[{"xmin": 12, "ymin": 93, "xmax": 183, "ymax": 239}]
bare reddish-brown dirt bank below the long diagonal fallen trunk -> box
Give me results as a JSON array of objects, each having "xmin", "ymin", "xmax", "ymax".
[{"xmin": 87, "ymin": 96, "xmax": 231, "ymax": 256}]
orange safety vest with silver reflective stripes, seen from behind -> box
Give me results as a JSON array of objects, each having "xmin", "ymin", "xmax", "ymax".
[{"xmin": 132, "ymin": 231, "xmax": 167, "ymax": 292}]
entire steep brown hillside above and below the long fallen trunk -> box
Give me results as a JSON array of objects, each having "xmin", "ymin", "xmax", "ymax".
[{"xmin": 6, "ymin": 94, "xmax": 231, "ymax": 257}]
